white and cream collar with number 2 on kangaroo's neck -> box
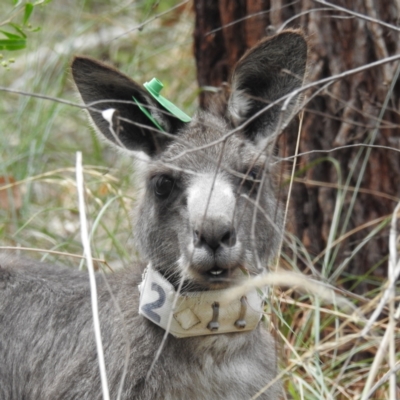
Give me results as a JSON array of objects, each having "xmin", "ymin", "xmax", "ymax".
[{"xmin": 139, "ymin": 265, "xmax": 264, "ymax": 338}]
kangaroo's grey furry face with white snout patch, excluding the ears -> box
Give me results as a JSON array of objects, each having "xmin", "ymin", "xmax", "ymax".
[{"xmin": 135, "ymin": 113, "xmax": 281, "ymax": 290}]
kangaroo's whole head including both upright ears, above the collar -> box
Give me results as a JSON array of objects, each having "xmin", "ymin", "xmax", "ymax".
[{"xmin": 72, "ymin": 31, "xmax": 307, "ymax": 290}]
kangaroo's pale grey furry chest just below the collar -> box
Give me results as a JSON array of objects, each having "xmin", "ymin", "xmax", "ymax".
[{"xmin": 139, "ymin": 328, "xmax": 279, "ymax": 400}]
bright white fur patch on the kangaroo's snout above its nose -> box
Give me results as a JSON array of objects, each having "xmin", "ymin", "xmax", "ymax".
[{"xmin": 187, "ymin": 173, "xmax": 235, "ymax": 225}]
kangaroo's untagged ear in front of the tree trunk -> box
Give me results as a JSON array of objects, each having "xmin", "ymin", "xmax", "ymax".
[{"xmin": 228, "ymin": 31, "xmax": 307, "ymax": 140}]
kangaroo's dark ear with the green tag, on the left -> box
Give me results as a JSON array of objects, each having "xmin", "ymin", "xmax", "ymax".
[{"xmin": 72, "ymin": 57, "xmax": 183, "ymax": 156}]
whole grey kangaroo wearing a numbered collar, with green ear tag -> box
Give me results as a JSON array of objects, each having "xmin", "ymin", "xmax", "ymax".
[{"xmin": 0, "ymin": 31, "xmax": 307, "ymax": 400}]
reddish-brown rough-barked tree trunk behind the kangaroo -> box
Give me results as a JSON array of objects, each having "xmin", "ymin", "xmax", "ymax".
[{"xmin": 195, "ymin": 0, "xmax": 400, "ymax": 291}]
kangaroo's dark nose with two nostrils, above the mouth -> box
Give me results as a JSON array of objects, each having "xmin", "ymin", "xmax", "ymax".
[{"xmin": 194, "ymin": 226, "xmax": 236, "ymax": 253}]
